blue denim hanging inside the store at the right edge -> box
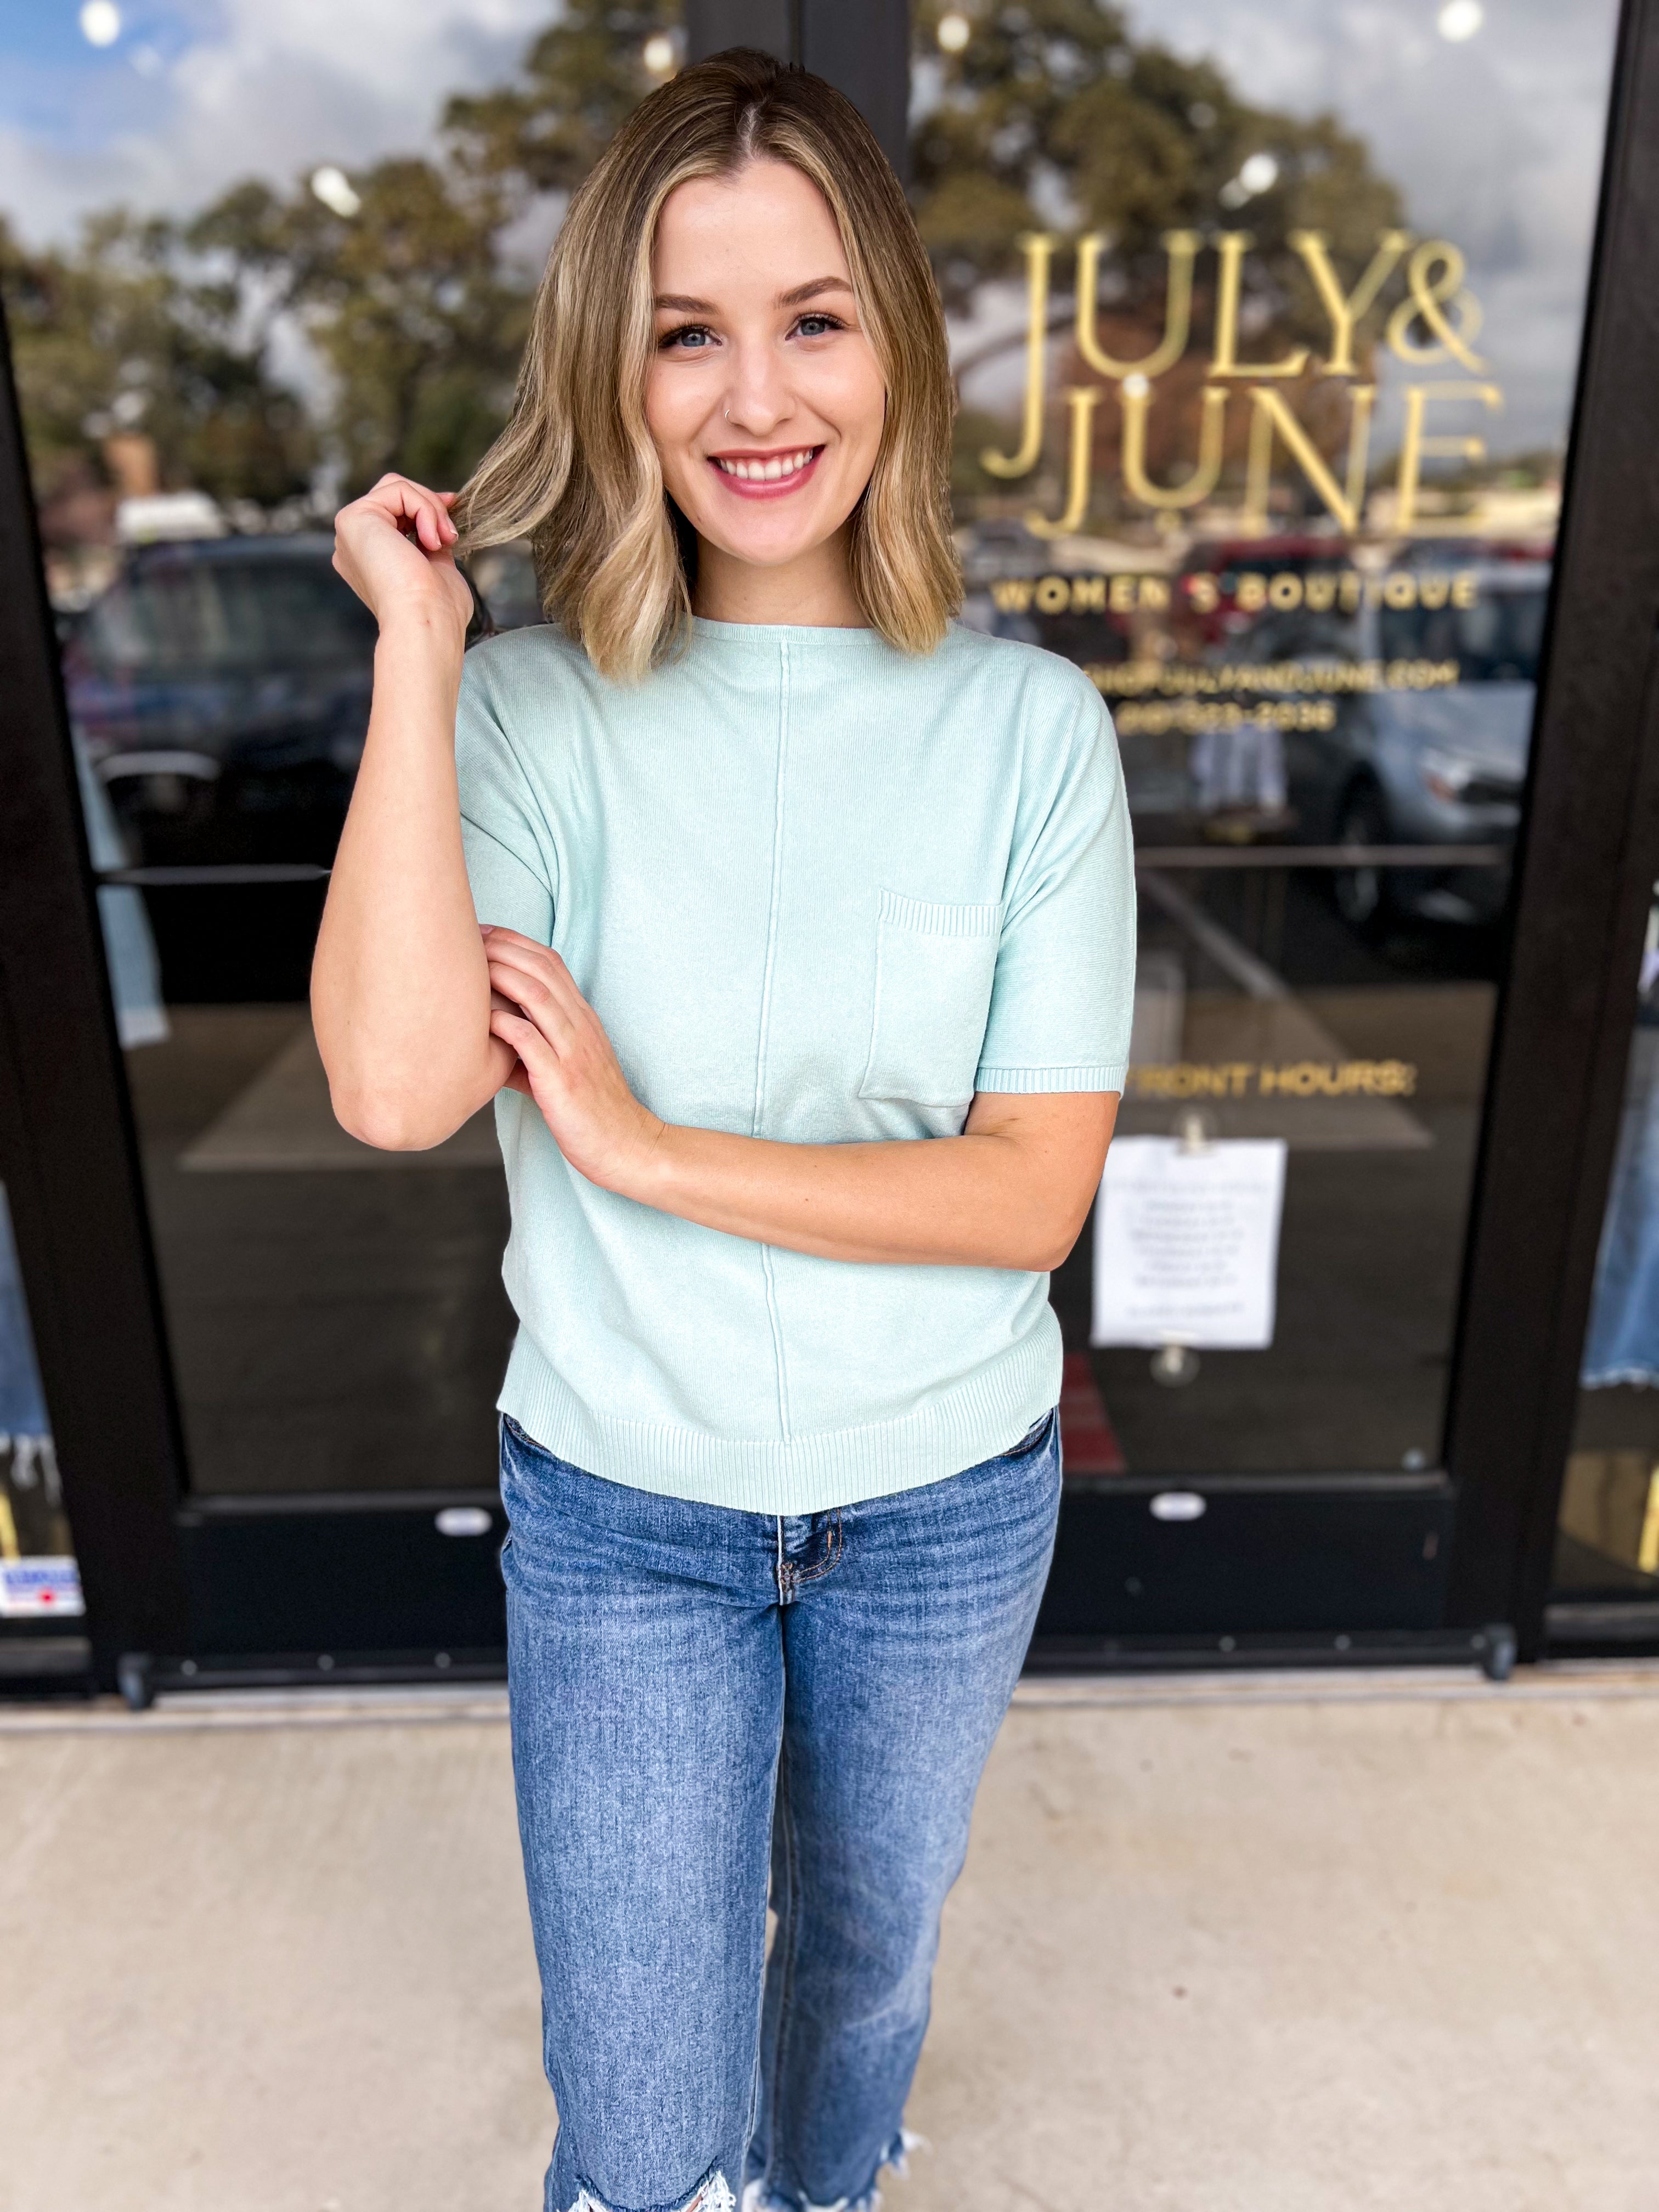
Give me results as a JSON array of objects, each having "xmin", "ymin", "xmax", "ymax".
[{"xmin": 1579, "ymin": 1007, "xmax": 1659, "ymax": 1389}]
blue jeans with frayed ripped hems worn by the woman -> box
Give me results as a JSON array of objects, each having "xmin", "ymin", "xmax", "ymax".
[{"xmin": 502, "ymin": 1415, "xmax": 1059, "ymax": 2212}]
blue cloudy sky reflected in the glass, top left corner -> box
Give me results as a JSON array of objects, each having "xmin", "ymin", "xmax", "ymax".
[{"xmin": 0, "ymin": 0, "xmax": 553, "ymax": 239}]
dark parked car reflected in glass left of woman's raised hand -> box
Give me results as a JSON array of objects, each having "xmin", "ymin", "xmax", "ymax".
[{"xmin": 64, "ymin": 535, "xmax": 535, "ymax": 865}]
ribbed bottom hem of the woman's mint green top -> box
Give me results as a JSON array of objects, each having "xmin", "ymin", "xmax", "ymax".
[{"xmin": 495, "ymin": 1307, "xmax": 1059, "ymax": 1513}]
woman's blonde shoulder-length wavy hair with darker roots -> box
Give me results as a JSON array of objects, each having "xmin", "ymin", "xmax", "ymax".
[{"xmin": 456, "ymin": 49, "xmax": 962, "ymax": 679}]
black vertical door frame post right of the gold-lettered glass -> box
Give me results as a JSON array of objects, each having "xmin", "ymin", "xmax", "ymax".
[{"xmin": 1447, "ymin": 0, "xmax": 1659, "ymax": 1657}]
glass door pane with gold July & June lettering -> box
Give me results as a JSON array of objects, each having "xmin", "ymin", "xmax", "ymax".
[{"xmin": 916, "ymin": 0, "xmax": 1617, "ymax": 1504}]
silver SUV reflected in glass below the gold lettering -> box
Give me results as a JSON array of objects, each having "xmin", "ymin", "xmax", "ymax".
[{"xmin": 1256, "ymin": 560, "xmax": 1548, "ymax": 927}]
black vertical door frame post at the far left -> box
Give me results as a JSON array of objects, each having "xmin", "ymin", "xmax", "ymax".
[{"xmin": 0, "ymin": 294, "xmax": 188, "ymax": 1681}]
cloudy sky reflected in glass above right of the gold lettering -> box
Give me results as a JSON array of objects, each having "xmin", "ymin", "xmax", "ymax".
[{"xmin": 1128, "ymin": 0, "xmax": 1617, "ymax": 452}]
